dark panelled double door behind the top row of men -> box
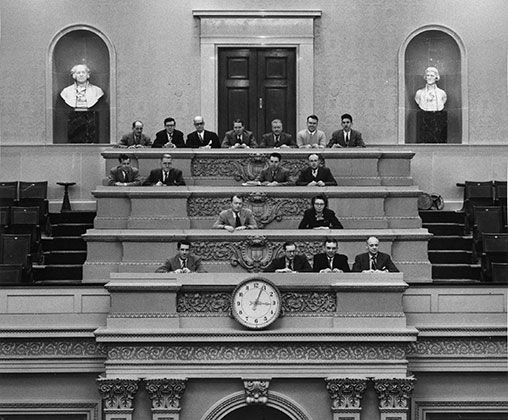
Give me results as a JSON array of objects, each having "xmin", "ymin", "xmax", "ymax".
[{"xmin": 219, "ymin": 48, "xmax": 296, "ymax": 141}]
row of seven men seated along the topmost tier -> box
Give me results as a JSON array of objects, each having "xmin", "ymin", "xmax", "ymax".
[{"xmin": 116, "ymin": 114, "xmax": 365, "ymax": 149}]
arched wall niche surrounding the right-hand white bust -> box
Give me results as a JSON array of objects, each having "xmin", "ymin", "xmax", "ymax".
[{"xmin": 399, "ymin": 25, "xmax": 468, "ymax": 144}]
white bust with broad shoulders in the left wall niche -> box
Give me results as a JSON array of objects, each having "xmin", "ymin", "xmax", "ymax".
[{"xmin": 60, "ymin": 64, "xmax": 104, "ymax": 109}]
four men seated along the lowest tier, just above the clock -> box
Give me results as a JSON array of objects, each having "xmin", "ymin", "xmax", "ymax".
[{"xmin": 156, "ymin": 236, "xmax": 399, "ymax": 273}]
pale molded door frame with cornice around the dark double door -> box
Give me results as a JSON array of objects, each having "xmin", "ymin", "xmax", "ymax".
[{"xmin": 192, "ymin": 10, "xmax": 321, "ymax": 136}]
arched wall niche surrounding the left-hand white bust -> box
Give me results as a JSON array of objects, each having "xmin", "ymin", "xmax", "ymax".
[{"xmin": 46, "ymin": 25, "xmax": 116, "ymax": 144}]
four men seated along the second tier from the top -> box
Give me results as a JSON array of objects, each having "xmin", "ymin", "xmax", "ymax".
[{"xmin": 108, "ymin": 152, "xmax": 337, "ymax": 187}]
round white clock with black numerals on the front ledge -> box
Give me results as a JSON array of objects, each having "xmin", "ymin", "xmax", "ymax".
[{"xmin": 231, "ymin": 278, "xmax": 282, "ymax": 330}]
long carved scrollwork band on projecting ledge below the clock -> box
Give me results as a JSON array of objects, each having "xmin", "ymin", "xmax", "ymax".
[{"xmin": 108, "ymin": 342, "xmax": 405, "ymax": 362}]
